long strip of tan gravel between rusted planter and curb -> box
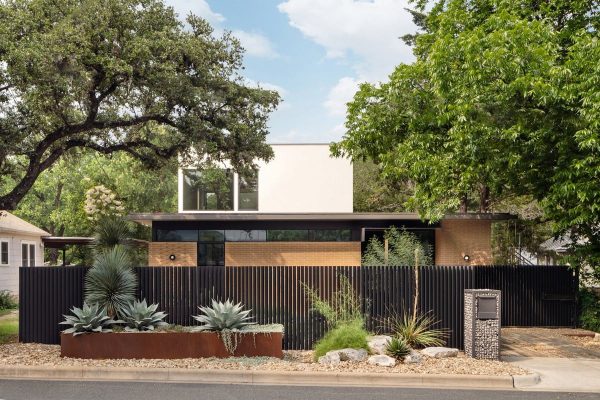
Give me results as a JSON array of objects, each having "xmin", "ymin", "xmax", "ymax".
[{"xmin": 0, "ymin": 343, "xmax": 527, "ymax": 375}]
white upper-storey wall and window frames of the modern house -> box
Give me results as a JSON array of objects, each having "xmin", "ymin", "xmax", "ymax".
[{"xmin": 178, "ymin": 144, "xmax": 353, "ymax": 213}]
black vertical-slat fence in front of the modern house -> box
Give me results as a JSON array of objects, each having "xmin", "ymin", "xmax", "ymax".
[{"xmin": 19, "ymin": 266, "xmax": 578, "ymax": 349}]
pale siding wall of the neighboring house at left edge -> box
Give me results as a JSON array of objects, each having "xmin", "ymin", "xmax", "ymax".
[{"xmin": 0, "ymin": 232, "xmax": 44, "ymax": 296}]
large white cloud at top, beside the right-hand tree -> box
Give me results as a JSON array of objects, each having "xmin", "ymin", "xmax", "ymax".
[{"xmin": 278, "ymin": 0, "xmax": 416, "ymax": 81}]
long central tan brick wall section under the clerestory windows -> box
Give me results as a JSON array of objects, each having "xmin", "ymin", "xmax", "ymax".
[{"xmin": 225, "ymin": 242, "xmax": 360, "ymax": 267}]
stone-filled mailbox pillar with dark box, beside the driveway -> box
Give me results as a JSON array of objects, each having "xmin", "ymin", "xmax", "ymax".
[{"xmin": 465, "ymin": 289, "xmax": 500, "ymax": 360}]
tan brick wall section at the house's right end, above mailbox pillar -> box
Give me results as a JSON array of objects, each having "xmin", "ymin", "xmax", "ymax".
[{"xmin": 435, "ymin": 220, "xmax": 492, "ymax": 265}]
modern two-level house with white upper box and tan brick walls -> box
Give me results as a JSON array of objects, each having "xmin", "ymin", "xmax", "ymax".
[{"xmin": 130, "ymin": 144, "xmax": 509, "ymax": 267}]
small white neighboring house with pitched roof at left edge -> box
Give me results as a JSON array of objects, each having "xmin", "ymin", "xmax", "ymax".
[{"xmin": 0, "ymin": 210, "xmax": 50, "ymax": 296}]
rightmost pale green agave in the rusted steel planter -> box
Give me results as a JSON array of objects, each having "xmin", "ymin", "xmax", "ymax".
[{"xmin": 193, "ymin": 300, "xmax": 256, "ymax": 331}]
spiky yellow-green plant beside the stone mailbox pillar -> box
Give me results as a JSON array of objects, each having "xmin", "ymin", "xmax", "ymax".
[{"xmin": 388, "ymin": 313, "xmax": 448, "ymax": 349}]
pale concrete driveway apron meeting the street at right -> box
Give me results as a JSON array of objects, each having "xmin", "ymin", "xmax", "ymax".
[{"xmin": 502, "ymin": 357, "xmax": 600, "ymax": 393}]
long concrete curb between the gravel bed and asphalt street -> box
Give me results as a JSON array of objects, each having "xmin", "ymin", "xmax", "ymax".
[{"xmin": 0, "ymin": 366, "xmax": 540, "ymax": 389}]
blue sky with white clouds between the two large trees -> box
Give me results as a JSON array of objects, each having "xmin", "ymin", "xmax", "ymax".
[{"xmin": 166, "ymin": 0, "xmax": 416, "ymax": 143}]
